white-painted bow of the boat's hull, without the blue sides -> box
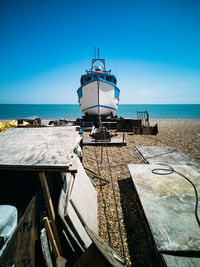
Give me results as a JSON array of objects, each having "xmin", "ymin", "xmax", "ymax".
[{"xmin": 80, "ymin": 81, "xmax": 119, "ymax": 115}]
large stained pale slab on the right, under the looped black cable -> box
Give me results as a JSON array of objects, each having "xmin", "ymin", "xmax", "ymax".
[{"xmin": 128, "ymin": 164, "xmax": 200, "ymax": 251}]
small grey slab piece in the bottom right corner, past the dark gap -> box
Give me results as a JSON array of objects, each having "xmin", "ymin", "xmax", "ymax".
[{"xmin": 162, "ymin": 254, "xmax": 200, "ymax": 267}]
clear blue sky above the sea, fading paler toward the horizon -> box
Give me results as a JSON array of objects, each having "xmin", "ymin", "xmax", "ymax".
[{"xmin": 0, "ymin": 0, "xmax": 200, "ymax": 104}]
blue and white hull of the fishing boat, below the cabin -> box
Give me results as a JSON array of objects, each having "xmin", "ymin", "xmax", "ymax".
[{"xmin": 78, "ymin": 79, "xmax": 119, "ymax": 116}]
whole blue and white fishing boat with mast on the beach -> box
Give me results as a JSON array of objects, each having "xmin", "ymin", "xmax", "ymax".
[{"xmin": 77, "ymin": 49, "xmax": 120, "ymax": 117}]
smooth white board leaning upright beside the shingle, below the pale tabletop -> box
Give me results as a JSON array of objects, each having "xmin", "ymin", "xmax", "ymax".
[{"xmin": 70, "ymin": 158, "xmax": 98, "ymax": 233}]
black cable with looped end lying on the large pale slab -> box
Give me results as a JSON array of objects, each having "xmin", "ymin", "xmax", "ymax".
[{"xmin": 152, "ymin": 163, "xmax": 200, "ymax": 227}]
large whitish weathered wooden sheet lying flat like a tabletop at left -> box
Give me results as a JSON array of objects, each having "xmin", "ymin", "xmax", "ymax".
[{"xmin": 0, "ymin": 126, "xmax": 80, "ymax": 170}]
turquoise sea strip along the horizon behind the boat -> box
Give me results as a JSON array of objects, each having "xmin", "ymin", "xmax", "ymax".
[{"xmin": 0, "ymin": 104, "xmax": 200, "ymax": 119}]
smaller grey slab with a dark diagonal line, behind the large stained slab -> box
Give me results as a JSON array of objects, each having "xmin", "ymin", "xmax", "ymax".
[{"xmin": 135, "ymin": 146, "xmax": 200, "ymax": 170}]
